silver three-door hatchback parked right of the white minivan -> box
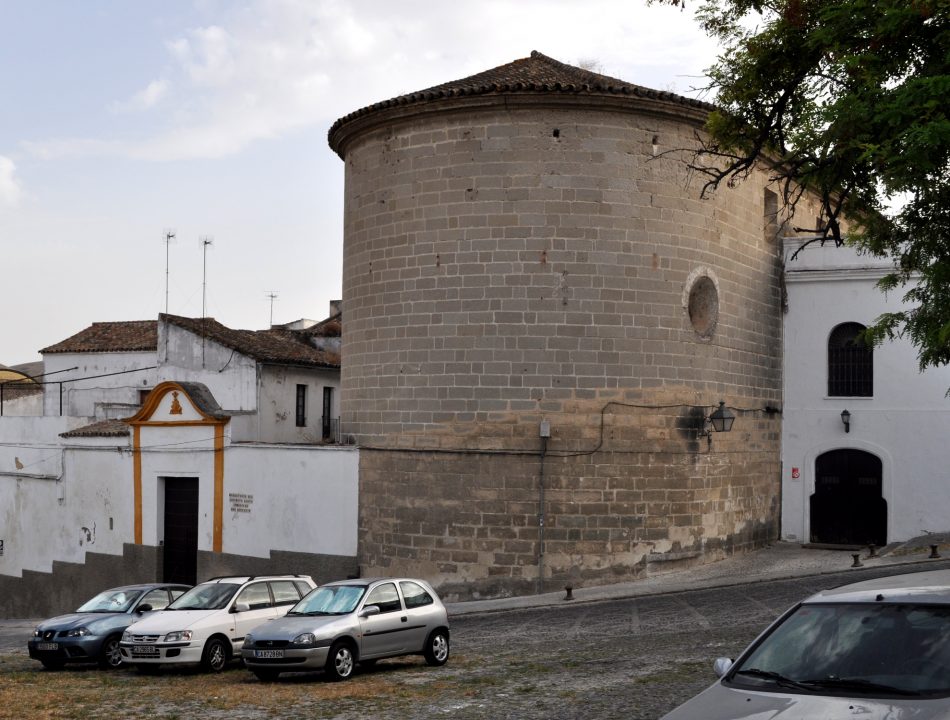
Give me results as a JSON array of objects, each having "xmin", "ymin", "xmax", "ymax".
[{"xmin": 241, "ymin": 578, "xmax": 449, "ymax": 680}]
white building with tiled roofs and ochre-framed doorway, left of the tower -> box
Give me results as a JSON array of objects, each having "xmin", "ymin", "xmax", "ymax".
[{"xmin": 0, "ymin": 306, "xmax": 358, "ymax": 617}]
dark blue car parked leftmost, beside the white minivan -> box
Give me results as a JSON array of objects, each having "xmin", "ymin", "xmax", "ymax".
[{"xmin": 28, "ymin": 583, "xmax": 190, "ymax": 670}]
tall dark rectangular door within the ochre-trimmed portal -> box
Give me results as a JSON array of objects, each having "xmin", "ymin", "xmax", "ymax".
[{"xmin": 162, "ymin": 478, "xmax": 198, "ymax": 585}]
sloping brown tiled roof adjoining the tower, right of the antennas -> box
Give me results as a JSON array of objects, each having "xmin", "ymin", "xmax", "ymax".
[{"xmin": 159, "ymin": 314, "xmax": 340, "ymax": 368}]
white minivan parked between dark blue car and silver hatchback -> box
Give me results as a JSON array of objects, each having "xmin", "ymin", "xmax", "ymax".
[{"xmin": 119, "ymin": 575, "xmax": 316, "ymax": 672}]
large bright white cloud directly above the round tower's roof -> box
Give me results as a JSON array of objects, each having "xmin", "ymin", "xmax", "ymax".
[{"xmin": 26, "ymin": 0, "xmax": 713, "ymax": 161}]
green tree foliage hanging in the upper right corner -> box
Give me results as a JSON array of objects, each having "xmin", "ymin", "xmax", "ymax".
[{"xmin": 654, "ymin": 0, "xmax": 950, "ymax": 368}]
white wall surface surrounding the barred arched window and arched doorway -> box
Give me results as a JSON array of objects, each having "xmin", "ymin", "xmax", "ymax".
[{"xmin": 782, "ymin": 241, "xmax": 950, "ymax": 542}]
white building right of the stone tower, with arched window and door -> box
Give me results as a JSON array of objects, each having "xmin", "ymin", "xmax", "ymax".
[{"xmin": 782, "ymin": 239, "xmax": 950, "ymax": 546}]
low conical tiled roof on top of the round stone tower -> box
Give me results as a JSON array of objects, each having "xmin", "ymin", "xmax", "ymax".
[{"xmin": 328, "ymin": 50, "xmax": 713, "ymax": 152}]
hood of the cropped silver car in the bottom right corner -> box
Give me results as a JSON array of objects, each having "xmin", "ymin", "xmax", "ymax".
[{"xmin": 663, "ymin": 683, "xmax": 950, "ymax": 720}]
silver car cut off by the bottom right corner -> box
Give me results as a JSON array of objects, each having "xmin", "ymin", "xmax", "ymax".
[{"xmin": 663, "ymin": 570, "xmax": 950, "ymax": 720}]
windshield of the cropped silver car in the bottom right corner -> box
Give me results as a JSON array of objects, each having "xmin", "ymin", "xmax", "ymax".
[{"xmin": 727, "ymin": 603, "xmax": 950, "ymax": 697}]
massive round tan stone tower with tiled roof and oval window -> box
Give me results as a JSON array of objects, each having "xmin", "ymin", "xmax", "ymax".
[{"xmin": 329, "ymin": 52, "xmax": 782, "ymax": 599}]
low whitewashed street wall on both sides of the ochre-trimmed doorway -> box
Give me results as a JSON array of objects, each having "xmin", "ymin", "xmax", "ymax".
[{"xmin": 0, "ymin": 418, "xmax": 358, "ymax": 577}]
